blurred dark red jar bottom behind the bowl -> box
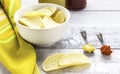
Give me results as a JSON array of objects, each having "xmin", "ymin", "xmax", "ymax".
[{"xmin": 65, "ymin": 0, "xmax": 87, "ymax": 10}]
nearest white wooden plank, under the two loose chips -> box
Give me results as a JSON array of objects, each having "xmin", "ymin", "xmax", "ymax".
[{"xmin": 36, "ymin": 49, "xmax": 120, "ymax": 74}]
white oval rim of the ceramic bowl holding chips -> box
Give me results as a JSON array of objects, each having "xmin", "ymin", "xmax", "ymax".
[{"xmin": 14, "ymin": 3, "xmax": 71, "ymax": 30}]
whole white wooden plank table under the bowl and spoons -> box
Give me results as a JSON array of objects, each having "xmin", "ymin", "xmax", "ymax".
[{"xmin": 0, "ymin": 0, "xmax": 120, "ymax": 74}]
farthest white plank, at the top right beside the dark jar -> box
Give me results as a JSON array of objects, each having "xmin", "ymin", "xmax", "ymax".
[{"xmin": 85, "ymin": 0, "xmax": 120, "ymax": 11}]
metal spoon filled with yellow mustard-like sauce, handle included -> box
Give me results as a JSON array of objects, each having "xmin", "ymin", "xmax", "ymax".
[{"xmin": 81, "ymin": 31, "xmax": 95, "ymax": 53}]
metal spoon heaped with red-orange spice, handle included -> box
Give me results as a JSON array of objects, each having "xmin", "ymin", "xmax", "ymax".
[{"xmin": 97, "ymin": 33, "xmax": 112, "ymax": 55}]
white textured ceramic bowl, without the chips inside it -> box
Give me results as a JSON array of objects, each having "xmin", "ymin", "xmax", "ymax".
[{"xmin": 14, "ymin": 3, "xmax": 70, "ymax": 46}]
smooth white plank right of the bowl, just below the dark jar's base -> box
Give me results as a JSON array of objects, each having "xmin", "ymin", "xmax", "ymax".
[{"xmin": 70, "ymin": 11, "xmax": 120, "ymax": 26}]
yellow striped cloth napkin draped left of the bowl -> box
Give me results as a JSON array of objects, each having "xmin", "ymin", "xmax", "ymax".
[{"xmin": 0, "ymin": 0, "xmax": 40, "ymax": 74}]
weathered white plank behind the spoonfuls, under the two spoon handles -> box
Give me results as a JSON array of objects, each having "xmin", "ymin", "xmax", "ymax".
[{"xmin": 36, "ymin": 24, "xmax": 120, "ymax": 50}]
